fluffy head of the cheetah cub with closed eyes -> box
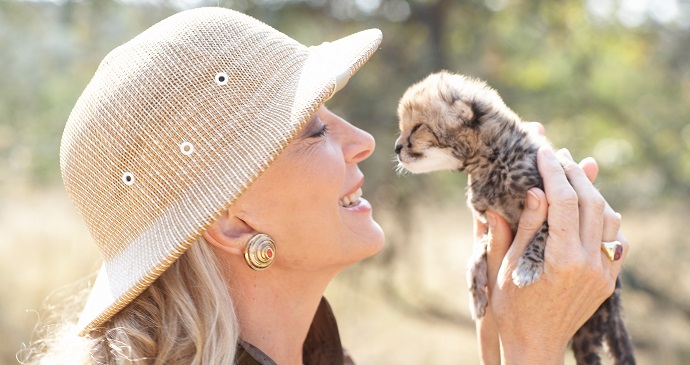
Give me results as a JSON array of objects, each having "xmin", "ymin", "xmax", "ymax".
[{"xmin": 395, "ymin": 71, "xmax": 507, "ymax": 173}]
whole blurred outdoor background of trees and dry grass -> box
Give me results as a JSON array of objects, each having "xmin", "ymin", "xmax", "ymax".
[{"xmin": 0, "ymin": 0, "xmax": 690, "ymax": 364}]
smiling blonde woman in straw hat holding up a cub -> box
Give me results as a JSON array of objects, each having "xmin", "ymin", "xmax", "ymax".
[{"xmin": 24, "ymin": 8, "xmax": 627, "ymax": 364}]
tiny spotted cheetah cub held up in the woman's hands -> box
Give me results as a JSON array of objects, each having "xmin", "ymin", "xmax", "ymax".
[{"xmin": 395, "ymin": 71, "xmax": 635, "ymax": 364}]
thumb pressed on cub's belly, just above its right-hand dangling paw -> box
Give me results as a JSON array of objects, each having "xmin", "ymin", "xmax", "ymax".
[{"xmin": 507, "ymin": 188, "xmax": 549, "ymax": 265}]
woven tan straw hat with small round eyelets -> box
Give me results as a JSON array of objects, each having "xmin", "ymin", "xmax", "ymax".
[{"xmin": 60, "ymin": 8, "xmax": 381, "ymax": 335}]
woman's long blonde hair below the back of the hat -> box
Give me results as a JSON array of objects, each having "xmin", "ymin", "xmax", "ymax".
[{"xmin": 17, "ymin": 237, "xmax": 239, "ymax": 365}]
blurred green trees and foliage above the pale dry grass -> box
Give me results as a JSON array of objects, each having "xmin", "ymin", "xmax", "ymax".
[{"xmin": 0, "ymin": 0, "xmax": 690, "ymax": 209}]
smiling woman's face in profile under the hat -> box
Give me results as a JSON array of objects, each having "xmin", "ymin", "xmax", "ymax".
[{"xmin": 231, "ymin": 107, "xmax": 384, "ymax": 272}]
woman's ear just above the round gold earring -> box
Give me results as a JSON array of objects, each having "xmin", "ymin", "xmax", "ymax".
[{"xmin": 202, "ymin": 212, "xmax": 257, "ymax": 256}]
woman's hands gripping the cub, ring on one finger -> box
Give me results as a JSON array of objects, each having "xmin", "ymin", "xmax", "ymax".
[{"xmin": 475, "ymin": 147, "xmax": 628, "ymax": 364}]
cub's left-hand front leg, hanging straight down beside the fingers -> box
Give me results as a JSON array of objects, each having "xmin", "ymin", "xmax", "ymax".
[{"xmin": 467, "ymin": 234, "xmax": 489, "ymax": 320}]
